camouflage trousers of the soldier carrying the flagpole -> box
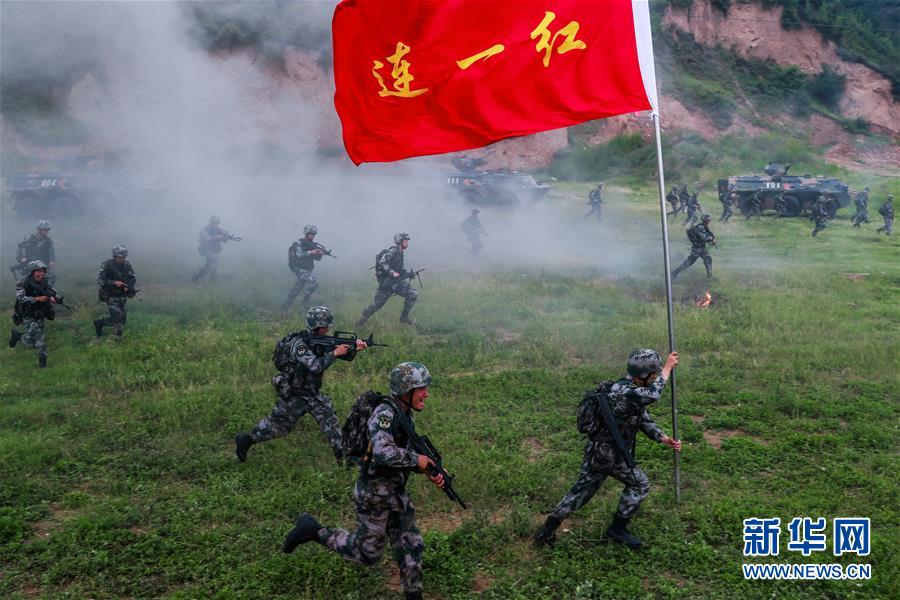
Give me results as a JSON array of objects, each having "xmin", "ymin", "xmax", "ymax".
[{"xmin": 553, "ymin": 442, "xmax": 650, "ymax": 521}]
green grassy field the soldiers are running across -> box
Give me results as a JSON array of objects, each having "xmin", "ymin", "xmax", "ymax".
[{"xmin": 0, "ymin": 180, "xmax": 900, "ymax": 599}]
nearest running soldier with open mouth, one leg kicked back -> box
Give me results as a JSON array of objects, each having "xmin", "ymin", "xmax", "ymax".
[{"xmin": 282, "ymin": 362, "xmax": 444, "ymax": 600}]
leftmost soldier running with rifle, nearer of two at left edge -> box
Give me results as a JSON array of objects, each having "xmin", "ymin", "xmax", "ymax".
[{"xmin": 9, "ymin": 260, "xmax": 61, "ymax": 368}]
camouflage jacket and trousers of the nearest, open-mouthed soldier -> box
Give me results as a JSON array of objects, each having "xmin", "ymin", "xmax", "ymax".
[{"xmin": 318, "ymin": 397, "xmax": 425, "ymax": 594}]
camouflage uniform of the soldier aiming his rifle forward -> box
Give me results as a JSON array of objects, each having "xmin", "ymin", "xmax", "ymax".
[{"xmin": 250, "ymin": 332, "xmax": 356, "ymax": 459}]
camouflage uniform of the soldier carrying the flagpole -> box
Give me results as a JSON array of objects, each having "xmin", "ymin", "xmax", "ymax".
[{"xmin": 552, "ymin": 375, "xmax": 666, "ymax": 521}]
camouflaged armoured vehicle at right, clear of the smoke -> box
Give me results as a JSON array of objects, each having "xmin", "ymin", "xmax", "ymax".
[{"xmin": 717, "ymin": 163, "xmax": 850, "ymax": 218}]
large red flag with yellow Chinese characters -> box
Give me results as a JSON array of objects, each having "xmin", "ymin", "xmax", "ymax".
[{"xmin": 332, "ymin": 0, "xmax": 656, "ymax": 164}]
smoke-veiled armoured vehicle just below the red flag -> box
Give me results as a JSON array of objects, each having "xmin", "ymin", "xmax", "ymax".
[{"xmin": 446, "ymin": 156, "xmax": 550, "ymax": 206}]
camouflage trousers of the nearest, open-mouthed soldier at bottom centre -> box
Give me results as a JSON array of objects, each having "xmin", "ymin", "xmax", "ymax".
[{"xmin": 319, "ymin": 478, "xmax": 425, "ymax": 592}]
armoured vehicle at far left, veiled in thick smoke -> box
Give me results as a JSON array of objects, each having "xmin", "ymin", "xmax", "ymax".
[{"xmin": 4, "ymin": 172, "xmax": 163, "ymax": 218}]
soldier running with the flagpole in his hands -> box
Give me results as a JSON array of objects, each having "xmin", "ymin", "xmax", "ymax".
[{"xmin": 534, "ymin": 350, "xmax": 681, "ymax": 550}]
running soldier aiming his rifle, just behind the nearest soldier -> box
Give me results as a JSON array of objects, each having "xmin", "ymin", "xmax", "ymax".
[{"xmin": 234, "ymin": 306, "xmax": 368, "ymax": 462}]
